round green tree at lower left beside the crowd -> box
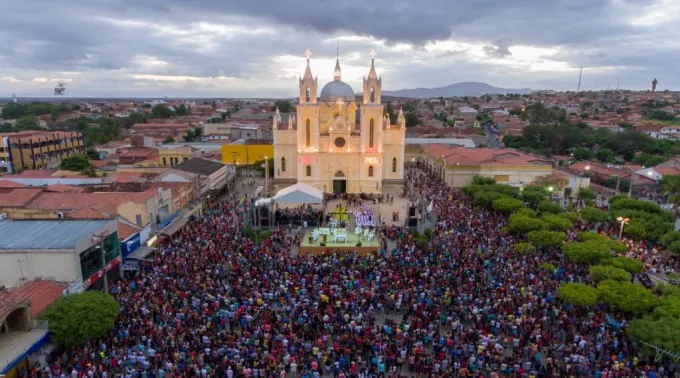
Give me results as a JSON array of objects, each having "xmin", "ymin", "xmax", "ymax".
[{"xmin": 41, "ymin": 291, "xmax": 120, "ymax": 347}]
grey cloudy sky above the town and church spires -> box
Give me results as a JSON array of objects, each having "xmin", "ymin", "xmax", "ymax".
[{"xmin": 0, "ymin": 0, "xmax": 680, "ymax": 97}]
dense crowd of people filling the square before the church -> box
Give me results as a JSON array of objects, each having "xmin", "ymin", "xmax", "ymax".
[{"xmin": 27, "ymin": 173, "xmax": 675, "ymax": 378}]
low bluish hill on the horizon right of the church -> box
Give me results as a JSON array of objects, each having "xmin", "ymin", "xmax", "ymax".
[{"xmin": 382, "ymin": 82, "xmax": 531, "ymax": 98}]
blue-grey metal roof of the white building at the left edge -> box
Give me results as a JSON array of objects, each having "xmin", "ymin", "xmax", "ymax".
[{"xmin": 0, "ymin": 219, "xmax": 112, "ymax": 250}]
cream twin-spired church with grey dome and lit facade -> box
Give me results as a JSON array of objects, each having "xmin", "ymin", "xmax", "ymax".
[{"xmin": 273, "ymin": 50, "xmax": 406, "ymax": 193}]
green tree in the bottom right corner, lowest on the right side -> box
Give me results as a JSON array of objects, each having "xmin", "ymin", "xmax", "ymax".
[{"xmin": 628, "ymin": 317, "xmax": 680, "ymax": 356}]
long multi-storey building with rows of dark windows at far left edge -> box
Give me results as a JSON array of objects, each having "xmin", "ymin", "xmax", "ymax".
[{"xmin": 0, "ymin": 131, "xmax": 85, "ymax": 174}]
